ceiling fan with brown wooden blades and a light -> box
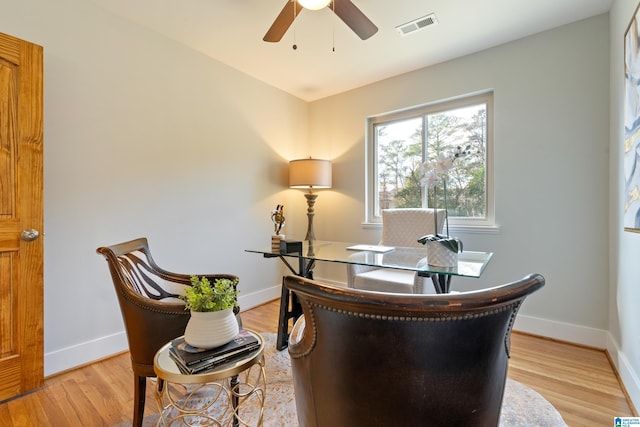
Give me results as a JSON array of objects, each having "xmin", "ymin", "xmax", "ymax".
[{"xmin": 262, "ymin": 0, "xmax": 378, "ymax": 42}]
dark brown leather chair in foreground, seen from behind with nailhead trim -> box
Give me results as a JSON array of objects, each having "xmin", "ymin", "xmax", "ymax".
[{"xmin": 285, "ymin": 274, "xmax": 545, "ymax": 427}]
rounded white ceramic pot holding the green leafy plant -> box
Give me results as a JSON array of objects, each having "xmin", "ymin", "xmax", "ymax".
[{"xmin": 184, "ymin": 308, "xmax": 239, "ymax": 348}]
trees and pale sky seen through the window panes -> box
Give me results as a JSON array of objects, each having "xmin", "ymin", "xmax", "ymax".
[{"xmin": 376, "ymin": 105, "xmax": 486, "ymax": 217}]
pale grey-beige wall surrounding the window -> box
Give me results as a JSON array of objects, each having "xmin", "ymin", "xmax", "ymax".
[{"xmin": 310, "ymin": 15, "xmax": 609, "ymax": 332}]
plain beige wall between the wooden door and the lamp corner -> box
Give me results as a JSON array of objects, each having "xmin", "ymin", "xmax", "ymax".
[{"xmin": 0, "ymin": 0, "xmax": 308, "ymax": 375}]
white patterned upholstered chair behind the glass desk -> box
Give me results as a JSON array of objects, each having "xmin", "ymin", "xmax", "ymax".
[{"xmin": 347, "ymin": 208, "xmax": 446, "ymax": 294}]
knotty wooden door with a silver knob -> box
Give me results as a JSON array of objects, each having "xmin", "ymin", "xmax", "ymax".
[{"xmin": 0, "ymin": 33, "xmax": 44, "ymax": 401}]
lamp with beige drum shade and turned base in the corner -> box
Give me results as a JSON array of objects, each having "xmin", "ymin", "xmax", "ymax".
[{"xmin": 289, "ymin": 158, "xmax": 331, "ymax": 240}]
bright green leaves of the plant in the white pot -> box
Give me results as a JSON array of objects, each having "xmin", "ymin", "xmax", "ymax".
[{"xmin": 180, "ymin": 275, "xmax": 239, "ymax": 311}]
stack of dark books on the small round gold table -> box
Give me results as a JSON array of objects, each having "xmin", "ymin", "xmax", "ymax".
[{"xmin": 169, "ymin": 329, "xmax": 260, "ymax": 374}]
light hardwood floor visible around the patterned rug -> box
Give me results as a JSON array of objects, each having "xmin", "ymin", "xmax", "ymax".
[{"xmin": 0, "ymin": 301, "xmax": 636, "ymax": 427}]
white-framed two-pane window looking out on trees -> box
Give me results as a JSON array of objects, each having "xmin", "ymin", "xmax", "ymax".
[{"xmin": 367, "ymin": 93, "xmax": 493, "ymax": 226}]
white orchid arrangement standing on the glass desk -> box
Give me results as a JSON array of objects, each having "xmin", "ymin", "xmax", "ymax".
[{"xmin": 418, "ymin": 146, "xmax": 470, "ymax": 253}]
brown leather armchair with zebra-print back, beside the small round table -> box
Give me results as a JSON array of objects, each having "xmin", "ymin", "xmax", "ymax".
[{"xmin": 97, "ymin": 238, "xmax": 240, "ymax": 427}]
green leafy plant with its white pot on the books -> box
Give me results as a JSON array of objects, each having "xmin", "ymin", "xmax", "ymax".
[{"xmin": 180, "ymin": 275, "xmax": 239, "ymax": 348}]
